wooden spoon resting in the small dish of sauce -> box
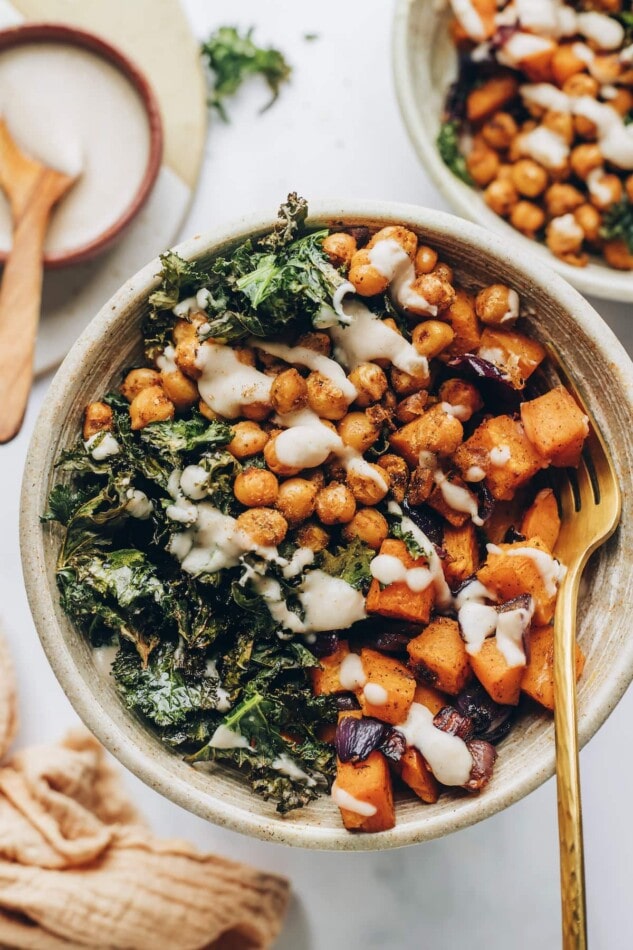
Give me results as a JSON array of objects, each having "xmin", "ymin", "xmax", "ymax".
[{"xmin": 0, "ymin": 119, "xmax": 77, "ymax": 443}]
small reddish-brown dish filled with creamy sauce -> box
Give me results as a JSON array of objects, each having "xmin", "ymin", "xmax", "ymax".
[{"xmin": 0, "ymin": 23, "xmax": 163, "ymax": 267}]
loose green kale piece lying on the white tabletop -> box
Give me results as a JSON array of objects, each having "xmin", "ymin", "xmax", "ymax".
[{"xmin": 201, "ymin": 26, "xmax": 292, "ymax": 122}]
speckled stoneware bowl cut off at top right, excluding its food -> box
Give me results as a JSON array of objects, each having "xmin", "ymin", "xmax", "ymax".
[{"xmin": 392, "ymin": 0, "xmax": 633, "ymax": 302}]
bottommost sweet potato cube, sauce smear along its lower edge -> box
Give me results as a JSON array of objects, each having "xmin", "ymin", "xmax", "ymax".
[{"xmin": 332, "ymin": 752, "xmax": 396, "ymax": 831}]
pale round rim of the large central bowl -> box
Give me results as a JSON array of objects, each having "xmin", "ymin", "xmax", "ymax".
[{"xmin": 20, "ymin": 200, "xmax": 633, "ymax": 851}]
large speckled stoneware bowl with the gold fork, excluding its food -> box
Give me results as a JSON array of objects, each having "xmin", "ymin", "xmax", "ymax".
[{"xmin": 21, "ymin": 202, "xmax": 633, "ymax": 850}]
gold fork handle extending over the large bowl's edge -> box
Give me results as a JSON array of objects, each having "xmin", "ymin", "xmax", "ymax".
[{"xmin": 554, "ymin": 565, "xmax": 587, "ymax": 950}]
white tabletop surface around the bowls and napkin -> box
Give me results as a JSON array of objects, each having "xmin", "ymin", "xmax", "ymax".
[{"xmin": 0, "ymin": 0, "xmax": 633, "ymax": 950}]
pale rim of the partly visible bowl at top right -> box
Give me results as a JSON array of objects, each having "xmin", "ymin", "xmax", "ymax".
[{"xmin": 391, "ymin": 0, "xmax": 633, "ymax": 303}]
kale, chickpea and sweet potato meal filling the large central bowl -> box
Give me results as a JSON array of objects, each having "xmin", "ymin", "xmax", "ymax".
[{"xmin": 47, "ymin": 196, "xmax": 587, "ymax": 831}]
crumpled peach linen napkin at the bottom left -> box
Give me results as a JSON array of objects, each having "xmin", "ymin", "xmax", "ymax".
[{"xmin": 0, "ymin": 635, "xmax": 289, "ymax": 950}]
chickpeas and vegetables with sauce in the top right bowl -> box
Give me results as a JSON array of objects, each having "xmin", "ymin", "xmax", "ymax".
[{"xmin": 437, "ymin": 0, "xmax": 633, "ymax": 270}]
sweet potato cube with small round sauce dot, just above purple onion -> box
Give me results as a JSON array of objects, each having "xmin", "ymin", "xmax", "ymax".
[{"xmin": 359, "ymin": 647, "xmax": 415, "ymax": 726}]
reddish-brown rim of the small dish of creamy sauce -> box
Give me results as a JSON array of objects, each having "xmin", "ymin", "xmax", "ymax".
[{"xmin": 0, "ymin": 23, "xmax": 163, "ymax": 268}]
